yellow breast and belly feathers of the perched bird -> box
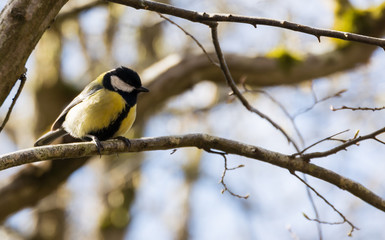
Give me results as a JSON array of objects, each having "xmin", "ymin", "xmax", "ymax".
[{"xmin": 63, "ymin": 89, "xmax": 136, "ymax": 138}]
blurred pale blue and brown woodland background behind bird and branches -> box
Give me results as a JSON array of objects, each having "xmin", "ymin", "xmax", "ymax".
[{"xmin": 0, "ymin": 0, "xmax": 385, "ymax": 240}]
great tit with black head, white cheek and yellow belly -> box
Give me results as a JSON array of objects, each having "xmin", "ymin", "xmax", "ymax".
[{"xmin": 35, "ymin": 66, "xmax": 149, "ymax": 153}]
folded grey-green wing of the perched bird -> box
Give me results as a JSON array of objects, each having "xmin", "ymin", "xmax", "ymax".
[{"xmin": 51, "ymin": 81, "xmax": 103, "ymax": 131}]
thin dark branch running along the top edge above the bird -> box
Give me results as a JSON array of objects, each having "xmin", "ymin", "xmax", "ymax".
[{"xmin": 109, "ymin": 0, "xmax": 385, "ymax": 49}]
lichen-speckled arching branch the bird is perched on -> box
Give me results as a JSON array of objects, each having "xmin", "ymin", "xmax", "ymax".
[{"xmin": 0, "ymin": 134, "xmax": 385, "ymax": 211}]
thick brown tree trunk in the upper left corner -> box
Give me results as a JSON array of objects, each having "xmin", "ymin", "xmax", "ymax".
[{"xmin": 0, "ymin": 0, "xmax": 68, "ymax": 106}]
